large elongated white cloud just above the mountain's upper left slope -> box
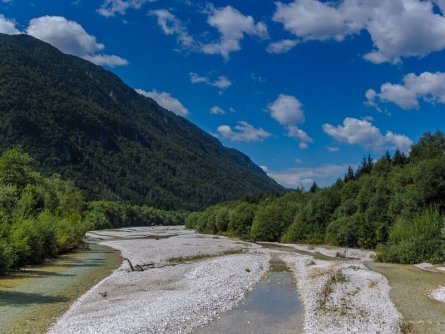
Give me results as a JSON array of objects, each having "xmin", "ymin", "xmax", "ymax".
[{"xmin": 26, "ymin": 16, "xmax": 128, "ymax": 67}]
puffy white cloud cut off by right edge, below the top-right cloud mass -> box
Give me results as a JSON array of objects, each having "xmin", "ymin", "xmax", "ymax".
[{"xmin": 365, "ymin": 72, "xmax": 445, "ymax": 109}]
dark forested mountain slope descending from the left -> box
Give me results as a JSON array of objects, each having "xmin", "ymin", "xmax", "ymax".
[{"xmin": 0, "ymin": 34, "xmax": 283, "ymax": 209}]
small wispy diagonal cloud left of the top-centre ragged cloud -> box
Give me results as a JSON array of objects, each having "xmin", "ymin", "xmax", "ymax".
[{"xmin": 150, "ymin": 9, "xmax": 195, "ymax": 48}]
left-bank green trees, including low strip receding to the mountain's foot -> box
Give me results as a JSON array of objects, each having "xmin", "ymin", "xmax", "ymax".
[{"xmin": 0, "ymin": 148, "xmax": 186, "ymax": 274}]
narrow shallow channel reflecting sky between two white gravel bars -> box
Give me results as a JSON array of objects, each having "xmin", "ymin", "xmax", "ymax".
[{"xmin": 195, "ymin": 258, "xmax": 304, "ymax": 334}]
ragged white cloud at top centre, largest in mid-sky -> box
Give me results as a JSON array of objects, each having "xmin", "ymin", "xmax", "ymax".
[{"xmin": 201, "ymin": 6, "xmax": 268, "ymax": 59}]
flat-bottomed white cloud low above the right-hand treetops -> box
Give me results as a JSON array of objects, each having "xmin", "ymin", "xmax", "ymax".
[{"xmin": 323, "ymin": 117, "xmax": 413, "ymax": 152}]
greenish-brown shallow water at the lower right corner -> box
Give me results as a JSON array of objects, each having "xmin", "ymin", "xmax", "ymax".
[{"xmin": 366, "ymin": 262, "xmax": 445, "ymax": 334}]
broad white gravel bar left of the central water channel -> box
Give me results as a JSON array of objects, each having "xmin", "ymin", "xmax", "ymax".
[{"xmin": 49, "ymin": 228, "xmax": 269, "ymax": 334}]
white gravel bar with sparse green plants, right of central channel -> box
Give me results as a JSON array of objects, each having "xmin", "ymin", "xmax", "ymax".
[{"xmin": 283, "ymin": 253, "xmax": 401, "ymax": 334}]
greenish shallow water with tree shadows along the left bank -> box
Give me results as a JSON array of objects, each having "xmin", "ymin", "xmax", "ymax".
[{"xmin": 0, "ymin": 243, "xmax": 121, "ymax": 334}]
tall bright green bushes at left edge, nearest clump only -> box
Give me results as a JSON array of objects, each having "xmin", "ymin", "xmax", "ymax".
[{"xmin": 0, "ymin": 148, "xmax": 91, "ymax": 273}]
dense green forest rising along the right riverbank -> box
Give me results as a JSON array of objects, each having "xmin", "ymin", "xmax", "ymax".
[{"xmin": 186, "ymin": 131, "xmax": 445, "ymax": 263}]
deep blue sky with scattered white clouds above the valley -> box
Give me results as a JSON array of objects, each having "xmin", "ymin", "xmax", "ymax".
[{"xmin": 0, "ymin": 0, "xmax": 445, "ymax": 187}]
